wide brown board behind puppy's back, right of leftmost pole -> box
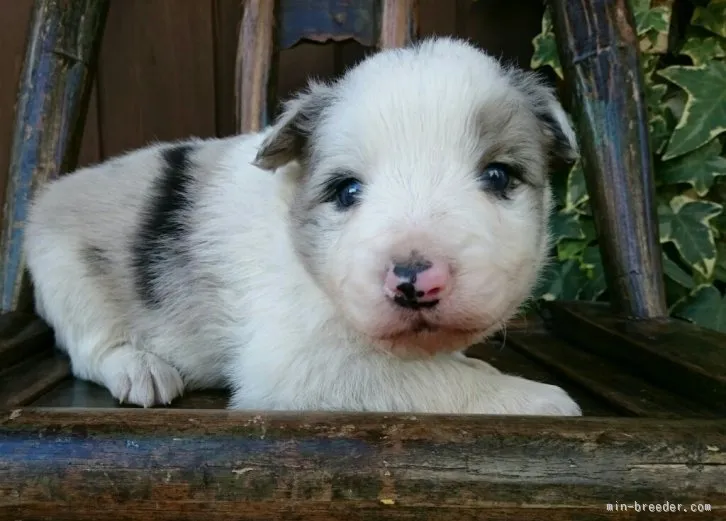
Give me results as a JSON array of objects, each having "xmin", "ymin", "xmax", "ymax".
[{"xmin": 98, "ymin": 0, "xmax": 219, "ymax": 157}]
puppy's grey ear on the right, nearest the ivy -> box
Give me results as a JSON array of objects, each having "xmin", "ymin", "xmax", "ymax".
[{"xmin": 510, "ymin": 70, "xmax": 580, "ymax": 165}]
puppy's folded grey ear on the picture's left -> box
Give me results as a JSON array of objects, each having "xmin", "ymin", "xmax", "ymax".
[{"xmin": 252, "ymin": 83, "xmax": 333, "ymax": 170}]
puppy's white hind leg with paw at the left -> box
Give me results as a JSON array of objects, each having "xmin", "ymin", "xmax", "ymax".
[{"xmin": 28, "ymin": 240, "xmax": 184, "ymax": 407}]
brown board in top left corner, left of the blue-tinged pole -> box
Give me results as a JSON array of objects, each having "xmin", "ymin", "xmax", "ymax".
[{"xmin": 0, "ymin": 0, "xmax": 33, "ymax": 221}]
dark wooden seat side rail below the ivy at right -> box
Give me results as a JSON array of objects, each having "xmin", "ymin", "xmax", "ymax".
[{"xmin": 543, "ymin": 302, "xmax": 726, "ymax": 413}]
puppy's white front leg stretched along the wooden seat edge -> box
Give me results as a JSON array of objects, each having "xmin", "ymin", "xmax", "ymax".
[{"xmin": 230, "ymin": 333, "xmax": 582, "ymax": 416}]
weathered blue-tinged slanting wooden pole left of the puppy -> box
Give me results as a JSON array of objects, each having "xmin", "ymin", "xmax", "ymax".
[{"xmin": 1, "ymin": 0, "xmax": 109, "ymax": 311}]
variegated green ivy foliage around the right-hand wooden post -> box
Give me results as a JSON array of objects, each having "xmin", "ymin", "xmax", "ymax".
[{"xmin": 531, "ymin": 0, "xmax": 726, "ymax": 332}]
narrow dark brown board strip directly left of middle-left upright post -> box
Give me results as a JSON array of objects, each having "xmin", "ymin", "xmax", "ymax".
[{"xmin": 213, "ymin": 0, "xmax": 244, "ymax": 137}]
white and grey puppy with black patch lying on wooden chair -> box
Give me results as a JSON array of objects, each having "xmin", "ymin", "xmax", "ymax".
[{"xmin": 25, "ymin": 38, "xmax": 581, "ymax": 415}]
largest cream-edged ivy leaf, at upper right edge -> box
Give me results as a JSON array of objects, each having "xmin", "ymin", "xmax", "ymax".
[{"xmin": 658, "ymin": 61, "xmax": 726, "ymax": 159}]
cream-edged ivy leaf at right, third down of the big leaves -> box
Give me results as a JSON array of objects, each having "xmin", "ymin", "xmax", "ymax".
[{"xmin": 658, "ymin": 195, "xmax": 722, "ymax": 277}]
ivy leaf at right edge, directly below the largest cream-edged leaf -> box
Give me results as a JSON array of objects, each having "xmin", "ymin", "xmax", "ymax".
[{"xmin": 658, "ymin": 140, "xmax": 726, "ymax": 197}]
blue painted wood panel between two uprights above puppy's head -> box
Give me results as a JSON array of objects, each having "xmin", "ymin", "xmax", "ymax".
[{"xmin": 278, "ymin": 0, "xmax": 381, "ymax": 49}]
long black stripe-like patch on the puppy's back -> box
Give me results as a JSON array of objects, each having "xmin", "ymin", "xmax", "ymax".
[{"xmin": 132, "ymin": 145, "xmax": 194, "ymax": 309}]
